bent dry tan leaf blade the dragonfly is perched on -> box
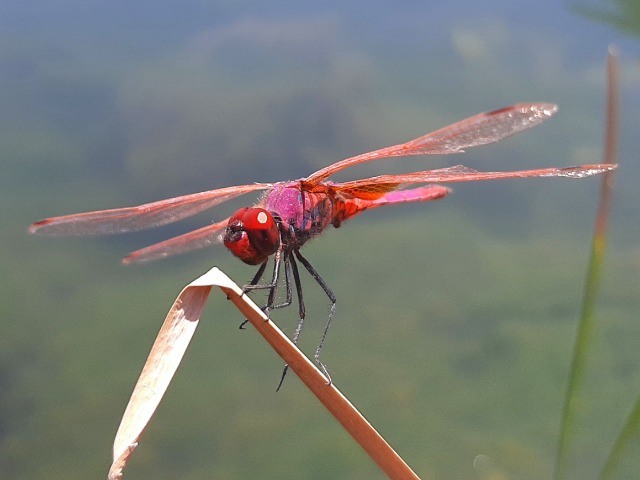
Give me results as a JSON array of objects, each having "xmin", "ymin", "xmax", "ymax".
[{"xmin": 109, "ymin": 267, "xmax": 419, "ymax": 480}]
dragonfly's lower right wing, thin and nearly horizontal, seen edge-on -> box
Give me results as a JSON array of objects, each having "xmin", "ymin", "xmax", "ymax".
[{"xmin": 335, "ymin": 164, "xmax": 617, "ymax": 188}]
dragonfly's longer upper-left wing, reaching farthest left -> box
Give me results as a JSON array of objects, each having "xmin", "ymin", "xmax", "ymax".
[{"xmin": 29, "ymin": 183, "xmax": 271, "ymax": 235}]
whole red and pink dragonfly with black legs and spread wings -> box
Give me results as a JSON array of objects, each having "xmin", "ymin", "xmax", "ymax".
[{"xmin": 29, "ymin": 103, "xmax": 616, "ymax": 388}]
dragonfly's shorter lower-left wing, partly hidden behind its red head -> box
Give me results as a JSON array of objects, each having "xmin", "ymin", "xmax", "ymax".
[{"xmin": 122, "ymin": 218, "xmax": 229, "ymax": 263}]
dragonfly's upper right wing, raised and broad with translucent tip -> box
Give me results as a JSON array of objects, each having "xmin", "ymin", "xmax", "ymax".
[{"xmin": 304, "ymin": 103, "xmax": 558, "ymax": 185}]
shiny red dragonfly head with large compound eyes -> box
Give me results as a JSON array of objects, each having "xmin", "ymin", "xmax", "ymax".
[{"xmin": 224, "ymin": 207, "xmax": 280, "ymax": 265}]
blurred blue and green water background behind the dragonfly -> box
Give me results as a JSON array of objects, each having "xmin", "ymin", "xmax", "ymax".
[{"xmin": 0, "ymin": 0, "xmax": 640, "ymax": 480}]
